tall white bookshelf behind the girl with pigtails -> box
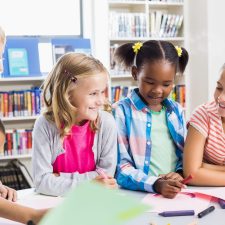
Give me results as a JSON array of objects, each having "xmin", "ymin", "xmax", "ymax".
[{"xmin": 108, "ymin": 0, "xmax": 186, "ymax": 107}]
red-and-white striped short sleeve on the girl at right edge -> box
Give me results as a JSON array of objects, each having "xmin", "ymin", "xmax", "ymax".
[{"xmin": 187, "ymin": 105, "xmax": 209, "ymax": 138}]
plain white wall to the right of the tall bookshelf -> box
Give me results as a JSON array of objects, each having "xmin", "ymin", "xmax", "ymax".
[{"xmin": 187, "ymin": 0, "xmax": 225, "ymax": 114}]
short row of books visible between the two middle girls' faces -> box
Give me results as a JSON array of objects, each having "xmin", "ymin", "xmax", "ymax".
[{"xmin": 111, "ymin": 86, "xmax": 135, "ymax": 103}]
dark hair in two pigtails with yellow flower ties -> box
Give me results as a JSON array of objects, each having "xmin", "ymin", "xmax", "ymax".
[{"xmin": 114, "ymin": 40, "xmax": 189, "ymax": 73}]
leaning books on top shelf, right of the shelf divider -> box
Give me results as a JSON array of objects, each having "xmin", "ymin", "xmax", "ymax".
[{"xmin": 149, "ymin": 10, "xmax": 183, "ymax": 37}]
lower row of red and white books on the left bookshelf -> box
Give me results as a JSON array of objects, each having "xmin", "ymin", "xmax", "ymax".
[{"xmin": 0, "ymin": 129, "xmax": 32, "ymax": 156}]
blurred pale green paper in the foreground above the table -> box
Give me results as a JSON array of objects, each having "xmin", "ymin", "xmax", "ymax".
[{"xmin": 39, "ymin": 182, "xmax": 150, "ymax": 225}]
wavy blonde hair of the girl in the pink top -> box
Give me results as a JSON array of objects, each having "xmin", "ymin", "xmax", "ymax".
[{"xmin": 43, "ymin": 52, "xmax": 109, "ymax": 137}]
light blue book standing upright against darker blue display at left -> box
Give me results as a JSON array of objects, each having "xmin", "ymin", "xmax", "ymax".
[{"xmin": 8, "ymin": 48, "xmax": 29, "ymax": 76}]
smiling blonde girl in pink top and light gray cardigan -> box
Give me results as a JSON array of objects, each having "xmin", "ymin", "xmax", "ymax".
[{"xmin": 32, "ymin": 53, "xmax": 117, "ymax": 196}]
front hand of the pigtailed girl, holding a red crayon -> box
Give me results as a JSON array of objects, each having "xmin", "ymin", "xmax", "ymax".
[{"xmin": 154, "ymin": 178, "xmax": 183, "ymax": 198}]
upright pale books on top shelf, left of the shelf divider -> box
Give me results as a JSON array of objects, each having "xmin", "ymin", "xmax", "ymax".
[{"xmin": 109, "ymin": 11, "xmax": 147, "ymax": 38}]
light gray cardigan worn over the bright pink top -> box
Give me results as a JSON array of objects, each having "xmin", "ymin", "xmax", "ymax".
[{"xmin": 32, "ymin": 111, "xmax": 117, "ymax": 196}]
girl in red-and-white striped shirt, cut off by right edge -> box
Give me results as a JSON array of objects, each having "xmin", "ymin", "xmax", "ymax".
[{"xmin": 184, "ymin": 64, "xmax": 225, "ymax": 186}]
